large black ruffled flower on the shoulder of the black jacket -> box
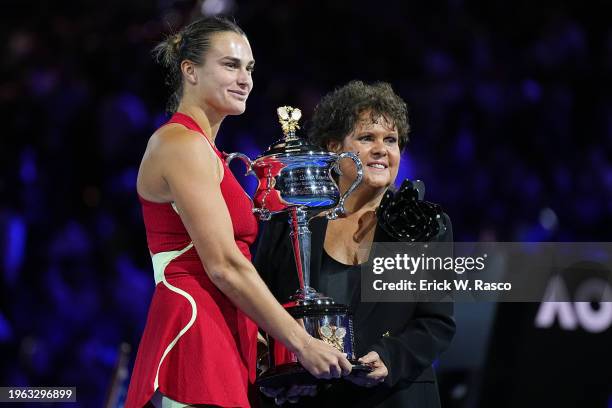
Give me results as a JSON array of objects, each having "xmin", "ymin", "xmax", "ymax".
[{"xmin": 376, "ymin": 179, "xmax": 446, "ymax": 242}]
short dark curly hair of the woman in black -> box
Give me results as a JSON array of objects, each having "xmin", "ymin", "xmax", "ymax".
[{"xmin": 308, "ymin": 81, "xmax": 410, "ymax": 149}]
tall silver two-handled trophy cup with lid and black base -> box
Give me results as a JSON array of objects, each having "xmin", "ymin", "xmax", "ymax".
[{"xmin": 226, "ymin": 106, "xmax": 367, "ymax": 387}]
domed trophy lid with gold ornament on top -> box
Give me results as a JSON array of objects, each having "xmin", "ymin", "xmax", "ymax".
[{"xmin": 257, "ymin": 106, "xmax": 331, "ymax": 159}]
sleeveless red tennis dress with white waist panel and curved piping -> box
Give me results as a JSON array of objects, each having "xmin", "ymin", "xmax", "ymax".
[{"xmin": 125, "ymin": 113, "xmax": 257, "ymax": 408}]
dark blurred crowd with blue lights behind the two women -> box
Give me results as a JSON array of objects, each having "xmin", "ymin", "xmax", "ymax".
[{"xmin": 0, "ymin": 0, "xmax": 612, "ymax": 406}]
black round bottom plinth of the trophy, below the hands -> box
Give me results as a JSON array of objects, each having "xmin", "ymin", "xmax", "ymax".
[{"xmin": 255, "ymin": 360, "xmax": 372, "ymax": 388}]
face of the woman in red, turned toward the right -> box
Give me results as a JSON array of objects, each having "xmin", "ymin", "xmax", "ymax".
[{"xmin": 194, "ymin": 31, "xmax": 255, "ymax": 117}]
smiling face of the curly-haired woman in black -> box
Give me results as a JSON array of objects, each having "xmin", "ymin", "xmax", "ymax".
[{"xmin": 329, "ymin": 110, "xmax": 401, "ymax": 190}]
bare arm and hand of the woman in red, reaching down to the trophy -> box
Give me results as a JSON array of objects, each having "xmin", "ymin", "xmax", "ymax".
[{"xmin": 152, "ymin": 131, "xmax": 351, "ymax": 378}]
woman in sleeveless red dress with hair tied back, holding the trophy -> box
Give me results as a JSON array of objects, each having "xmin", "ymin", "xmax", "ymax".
[{"xmin": 125, "ymin": 18, "xmax": 351, "ymax": 408}]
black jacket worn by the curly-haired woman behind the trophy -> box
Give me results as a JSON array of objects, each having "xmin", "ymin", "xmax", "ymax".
[{"xmin": 254, "ymin": 215, "xmax": 455, "ymax": 408}]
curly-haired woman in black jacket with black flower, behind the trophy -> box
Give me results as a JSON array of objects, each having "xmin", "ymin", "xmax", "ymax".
[{"xmin": 254, "ymin": 81, "xmax": 455, "ymax": 407}]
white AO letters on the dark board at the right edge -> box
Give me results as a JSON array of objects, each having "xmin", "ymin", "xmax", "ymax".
[{"xmin": 535, "ymin": 277, "xmax": 612, "ymax": 333}]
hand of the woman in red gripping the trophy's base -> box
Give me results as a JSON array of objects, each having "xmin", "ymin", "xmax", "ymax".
[{"xmin": 295, "ymin": 335, "xmax": 353, "ymax": 379}]
